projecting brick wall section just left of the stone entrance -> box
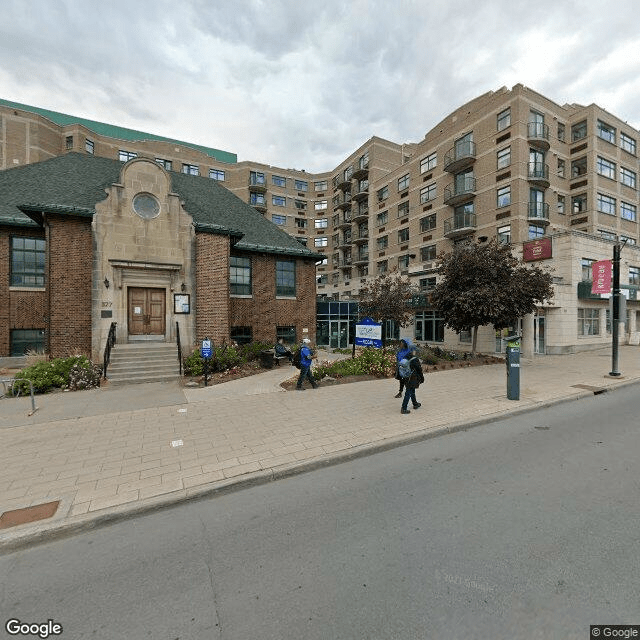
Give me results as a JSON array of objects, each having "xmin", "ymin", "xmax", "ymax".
[{"xmin": 47, "ymin": 215, "xmax": 93, "ymax": 357}]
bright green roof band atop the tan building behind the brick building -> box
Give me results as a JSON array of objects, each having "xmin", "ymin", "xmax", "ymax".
[{"xmin": 0, "ymin": 98, "xmax": 238, "ymax": 164}]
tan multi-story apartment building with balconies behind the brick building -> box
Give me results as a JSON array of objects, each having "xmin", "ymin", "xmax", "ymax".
[{"xmin": 0, "ymin": 85, "xmax": 640, "ymax": 353}]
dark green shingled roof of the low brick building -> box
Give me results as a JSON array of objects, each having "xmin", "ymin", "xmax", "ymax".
[{"xmin": 0, "ymin": 153, "xmax": 324, "ymax": 260}]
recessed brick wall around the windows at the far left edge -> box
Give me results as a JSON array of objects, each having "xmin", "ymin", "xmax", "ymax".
[{"xmin": 0, "ymin": 227, "xmax": 48, "ymax": 356}]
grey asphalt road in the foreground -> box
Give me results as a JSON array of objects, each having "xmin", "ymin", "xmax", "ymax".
[{"xmin": 0, "ymin": 386, "xmax": 640, "ymax": 640}]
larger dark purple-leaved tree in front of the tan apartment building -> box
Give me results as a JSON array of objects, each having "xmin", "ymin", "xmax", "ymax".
[{"xmin": 431, "ymin": 240, "xmax": 553, "ymax": 353}]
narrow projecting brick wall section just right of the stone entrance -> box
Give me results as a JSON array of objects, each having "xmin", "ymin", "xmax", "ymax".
[{"xmin": 192, "ymin": 233, "xmax": 229, "ymax": 344}]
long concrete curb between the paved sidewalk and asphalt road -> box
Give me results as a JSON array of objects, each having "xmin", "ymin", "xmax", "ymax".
[{"xmin": 0, "ymin": 379, "xmax": 640, "ymax": 555}]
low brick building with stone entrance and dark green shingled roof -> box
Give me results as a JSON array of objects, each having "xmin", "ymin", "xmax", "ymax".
[{"xmin": 0, "ymin": 152, "xmax": 319, "ymax": 359}]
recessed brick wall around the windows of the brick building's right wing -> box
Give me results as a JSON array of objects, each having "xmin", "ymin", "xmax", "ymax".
[{"xmin": 230, "ymin": 254, "xmax": 316, "ymax": 342}]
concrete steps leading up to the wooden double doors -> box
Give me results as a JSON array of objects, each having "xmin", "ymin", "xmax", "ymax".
[{"xmin": 107, "ymin": 342, "xmax": 180, "ymax": 385}]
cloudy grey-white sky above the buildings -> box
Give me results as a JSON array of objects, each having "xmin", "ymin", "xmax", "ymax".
[{"xmin": 0, "ymin": 0, "xmax": 640, "ymax": 172}]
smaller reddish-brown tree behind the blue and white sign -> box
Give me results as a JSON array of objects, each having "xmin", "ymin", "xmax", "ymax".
[{"xmin": 358, "ymin": 271, "xmax": 416, "ymax": 342}]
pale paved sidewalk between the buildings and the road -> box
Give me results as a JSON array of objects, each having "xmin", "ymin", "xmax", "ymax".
[{"xmin": 0, "ymin": 346, "xmax": 640, "ymax": 551}]
